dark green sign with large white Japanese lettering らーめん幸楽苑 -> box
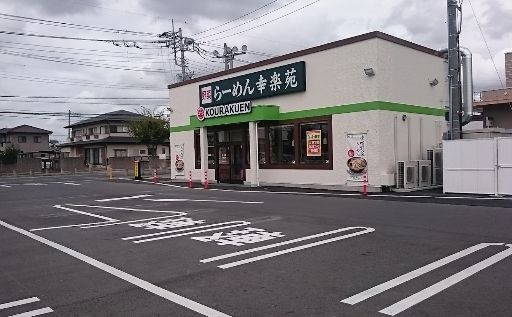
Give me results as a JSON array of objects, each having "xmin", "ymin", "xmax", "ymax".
[{"xmin": 199, "ymin": 62, "xmax": 306, "ymax": 108}]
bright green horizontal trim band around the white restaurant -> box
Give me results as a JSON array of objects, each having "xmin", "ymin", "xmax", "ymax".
[{"xmin": 171, "ymin": 101, "xmax": 446, "ymax": 132}]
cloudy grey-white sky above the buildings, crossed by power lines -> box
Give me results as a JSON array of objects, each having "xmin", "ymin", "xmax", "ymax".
[{"xmin": 0, "ymin": 0, "xmax": 512, "ymax": 142}]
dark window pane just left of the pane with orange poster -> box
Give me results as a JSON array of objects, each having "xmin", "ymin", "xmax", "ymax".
[{"xmin": 269, "ymin": 124, "xmax": 295, "ymax": 164}]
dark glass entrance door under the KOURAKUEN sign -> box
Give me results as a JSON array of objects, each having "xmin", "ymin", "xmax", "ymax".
[{"xmin": 217, "ymin": 142, "xmax": 245, "ymax": 183}]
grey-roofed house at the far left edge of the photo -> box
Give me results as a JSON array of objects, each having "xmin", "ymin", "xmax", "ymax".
[{"xmin": 0, "ymin": 124, "xmax": 53, "ymax": 157}]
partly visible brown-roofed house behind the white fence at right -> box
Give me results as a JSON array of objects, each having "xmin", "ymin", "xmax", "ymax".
[{"xmin": 475, "ymin": 52, "xmax": 512, "ymax": 129}]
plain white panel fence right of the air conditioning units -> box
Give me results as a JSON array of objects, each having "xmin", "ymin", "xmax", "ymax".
[{"xmin": 443, "ymin": 138, "xmax": 512, "ymax": 195}]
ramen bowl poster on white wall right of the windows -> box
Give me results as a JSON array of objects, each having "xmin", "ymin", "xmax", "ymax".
[{"xmin": 347, "ymin": 133, "xmax": 368, "ymax": 182}]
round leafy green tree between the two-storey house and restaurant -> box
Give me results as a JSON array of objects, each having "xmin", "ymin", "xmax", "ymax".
[{"xmin": 128, "ymin": 107, "xmax": 169, "ymax": 156}]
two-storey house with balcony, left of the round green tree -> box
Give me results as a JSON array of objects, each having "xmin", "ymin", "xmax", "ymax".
[{"xmin": 59, "ymin": 110, "xmax": 169, "ymax": 165}]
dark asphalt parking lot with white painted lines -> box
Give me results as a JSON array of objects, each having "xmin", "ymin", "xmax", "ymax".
[{"xmin": 0, "ymin": 176, "xmax": 512, "ymax": 317}]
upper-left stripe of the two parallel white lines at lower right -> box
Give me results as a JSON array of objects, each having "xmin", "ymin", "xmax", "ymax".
[{"xmin": 341, "ymin": 243, "xmax": 503, "ymax": 305}]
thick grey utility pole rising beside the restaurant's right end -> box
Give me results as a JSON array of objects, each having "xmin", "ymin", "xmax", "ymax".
[{"xmin": 447, "ymin": 0, "xmax": 462, "ymax": 140}]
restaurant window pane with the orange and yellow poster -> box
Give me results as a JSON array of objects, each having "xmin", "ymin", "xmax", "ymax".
[{"xmin": 299, "ymin": 122, "xmax": 330, "ymax": 164}]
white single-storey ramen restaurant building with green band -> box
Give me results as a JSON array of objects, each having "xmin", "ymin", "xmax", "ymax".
[{"xmin": 168, "ymin": 32, "xmax": 448, "ymax": 190}]
